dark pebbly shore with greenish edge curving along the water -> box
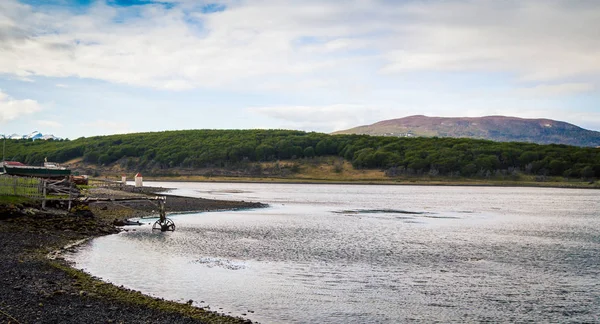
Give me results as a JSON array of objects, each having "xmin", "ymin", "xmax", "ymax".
[{"xmin": 0, "ymin": 188, "xmax": 264, "ymax": 323}]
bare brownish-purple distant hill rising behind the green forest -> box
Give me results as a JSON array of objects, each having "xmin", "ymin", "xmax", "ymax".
[{"xmin": 334, "ymin": 115, "xmax": 600, "ymax": 146}]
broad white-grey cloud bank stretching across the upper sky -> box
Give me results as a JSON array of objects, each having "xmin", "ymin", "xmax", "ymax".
[{"xmin": 0, "ymin": 0, "xmax": 600, "ymax": 90}]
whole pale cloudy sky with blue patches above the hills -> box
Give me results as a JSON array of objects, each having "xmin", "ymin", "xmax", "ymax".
[{"xmin": 0, "ymin": 0, "xmax": 600, "ymax": 139}]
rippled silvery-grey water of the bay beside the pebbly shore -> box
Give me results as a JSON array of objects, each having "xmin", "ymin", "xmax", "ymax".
[{"xmin": 65, "ymin": 183, "xmax": 600, "ymax": 323}]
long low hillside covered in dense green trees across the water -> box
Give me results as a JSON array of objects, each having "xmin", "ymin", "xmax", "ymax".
[{"xmin": 6, "ymin": 130, "xmax": 600, "ymax": 178}]
